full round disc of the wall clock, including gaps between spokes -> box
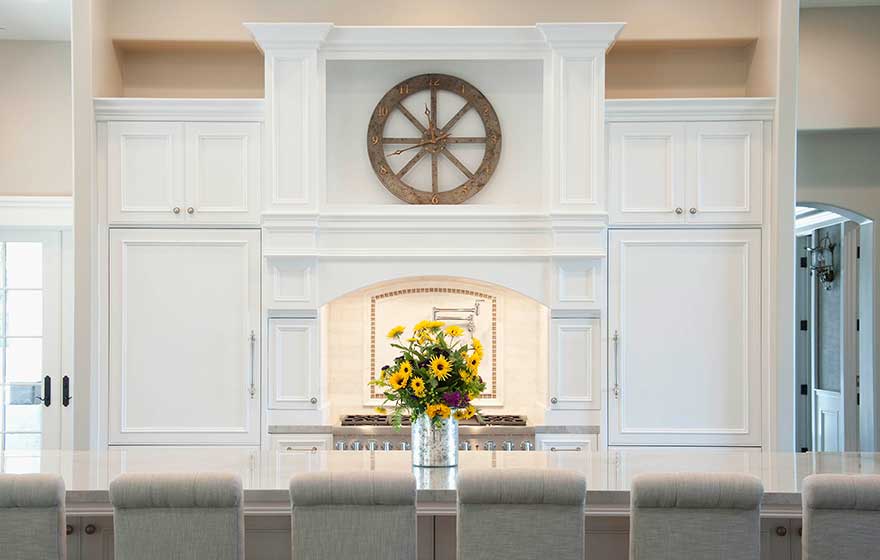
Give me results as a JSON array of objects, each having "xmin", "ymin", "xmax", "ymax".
[{"xmin": 367, "ymin": 74, "xmax": 501, "ymax": 204}]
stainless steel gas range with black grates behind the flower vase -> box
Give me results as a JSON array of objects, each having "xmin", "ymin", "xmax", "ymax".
[{"xmin": 333, "ymin": 414, "xmax": 535, "ymax": 451}]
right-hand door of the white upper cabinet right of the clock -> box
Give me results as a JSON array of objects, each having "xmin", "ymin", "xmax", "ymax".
[{"xmin": 687, "ymin": 121, "xmax": 764, "ymax": 224}]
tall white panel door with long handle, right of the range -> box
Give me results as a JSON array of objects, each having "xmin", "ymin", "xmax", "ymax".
[{"xmin": 608, "ymin": 229, "xmax": 762, "ymax": 446}]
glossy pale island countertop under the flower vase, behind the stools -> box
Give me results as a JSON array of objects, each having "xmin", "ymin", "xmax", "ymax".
[{"xmin": 8, "ymin": 447, "xmax": 880, "ymax": 517}]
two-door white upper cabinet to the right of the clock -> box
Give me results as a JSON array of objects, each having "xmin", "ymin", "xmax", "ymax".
[{"xmin": 608, "ymin": 121, "xmax": 765, "ymax": 224}]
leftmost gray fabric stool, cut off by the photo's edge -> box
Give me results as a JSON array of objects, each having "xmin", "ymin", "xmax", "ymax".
[{"xmin": 0, "ymin": 474, "xmax": 67, "ymax": 560}]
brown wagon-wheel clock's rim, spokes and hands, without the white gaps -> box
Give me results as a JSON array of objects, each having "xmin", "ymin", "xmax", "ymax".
[{"xmin": 367, "ymin": 74, "xmax": 501, "ymax": 204}]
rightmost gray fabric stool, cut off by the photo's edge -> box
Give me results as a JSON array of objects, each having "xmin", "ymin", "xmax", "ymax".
[{"xmin": 802, "ymin": 474, "xmax": 880, "ymax": 560}]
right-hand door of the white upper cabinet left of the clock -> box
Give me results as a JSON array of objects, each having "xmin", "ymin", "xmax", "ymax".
[{"xmin": 186, "ymin": 122, "xmax": 260, "ymax": 224}]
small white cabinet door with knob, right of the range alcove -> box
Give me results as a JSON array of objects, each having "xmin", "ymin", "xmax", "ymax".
[{"xmin": 550, "ymin": 318, "xmax": 602, "ymax": 410}]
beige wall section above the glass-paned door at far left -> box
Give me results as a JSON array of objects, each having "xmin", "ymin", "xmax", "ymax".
[{"xmin": 0, "ymin": 41, "xmax": 73, "ymax": 195}]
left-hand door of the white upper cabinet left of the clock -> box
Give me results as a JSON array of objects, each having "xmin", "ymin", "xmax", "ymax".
[{"xmin": 107, "ymin": 122, "xmax": 184, "ymax": 224}]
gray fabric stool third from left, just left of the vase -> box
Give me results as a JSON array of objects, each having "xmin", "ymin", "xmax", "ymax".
[{"xmin": 290, "ymin": 472, "xmax": 416, "ymax": 560}]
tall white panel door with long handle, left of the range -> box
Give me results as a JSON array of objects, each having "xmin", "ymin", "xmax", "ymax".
[{"xmin": 108, "ymin": 229, "xmax": 260, "ymax": 445}]
